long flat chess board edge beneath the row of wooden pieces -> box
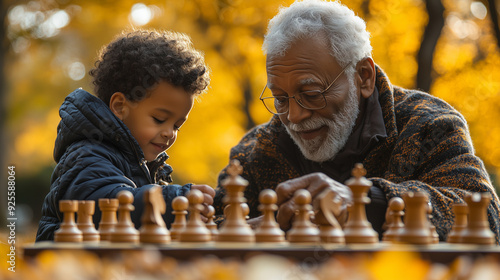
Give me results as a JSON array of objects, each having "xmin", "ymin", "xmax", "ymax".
[{"xmin": 23, "ymin": 241, "xmax": 500, "ymax": 264}]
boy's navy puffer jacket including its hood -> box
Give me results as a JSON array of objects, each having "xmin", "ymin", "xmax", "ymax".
[{"xmin": 36, "ymin": 89, "xmax": 191, "ymax": 241}]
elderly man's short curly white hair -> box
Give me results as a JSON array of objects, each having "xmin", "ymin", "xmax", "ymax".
[{"xmin": 262, "ymin": 0, "xmax": 372, "ymax": 74}]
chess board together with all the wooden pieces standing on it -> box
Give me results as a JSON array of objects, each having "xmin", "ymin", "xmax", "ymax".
[{"xmin": 23, "ymin": 160, "xmax": 500, "ymax": 264}]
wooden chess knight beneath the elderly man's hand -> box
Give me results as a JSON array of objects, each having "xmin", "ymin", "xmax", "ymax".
[{"xmin": 313, "ymin": 188, "xmax": 345, "ymax": 244}]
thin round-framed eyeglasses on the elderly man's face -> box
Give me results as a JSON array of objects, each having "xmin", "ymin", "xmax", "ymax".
[{"xmin": 259, "ymin": 62, "xmax": 351, "ymax": 115}]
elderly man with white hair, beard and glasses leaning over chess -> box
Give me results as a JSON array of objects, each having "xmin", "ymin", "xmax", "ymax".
[{"xmin": 214, "ymin": 0, "xmax": 500, "ymax": 242}]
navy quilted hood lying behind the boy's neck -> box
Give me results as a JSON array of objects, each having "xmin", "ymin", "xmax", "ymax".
[{"xmin": 54, "ymin": 89, "xmax": 144, "ymax": 162}]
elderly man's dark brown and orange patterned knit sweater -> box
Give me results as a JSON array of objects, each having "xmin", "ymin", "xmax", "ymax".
[{"xmin": 214, "ymin": 66, "xmax": 500, "ymax": 243}]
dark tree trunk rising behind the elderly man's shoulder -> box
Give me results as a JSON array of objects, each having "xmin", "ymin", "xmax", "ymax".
[{"xmin": 416, "ymin": 0, "xmax": 444, "ymax": 92}]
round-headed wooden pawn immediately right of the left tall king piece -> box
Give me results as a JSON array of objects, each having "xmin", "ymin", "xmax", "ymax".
[{"xmin": 255, "ymin": 189, "xmax": 285, "ymax": 243}]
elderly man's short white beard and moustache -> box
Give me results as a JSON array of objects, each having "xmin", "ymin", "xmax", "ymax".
[{"xmin": 285, "ymin": 79, "xmax": 359, "ymax": 162}]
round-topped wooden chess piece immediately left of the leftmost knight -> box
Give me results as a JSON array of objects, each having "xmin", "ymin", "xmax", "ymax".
[{"xmin": 110, "ymin": 190, "xmax": 139, "ymax": 243}]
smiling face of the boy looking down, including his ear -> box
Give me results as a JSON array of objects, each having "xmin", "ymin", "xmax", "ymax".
[{"xmin": 109, "ymin": 81, "xmax": 194, "ymax": 161}]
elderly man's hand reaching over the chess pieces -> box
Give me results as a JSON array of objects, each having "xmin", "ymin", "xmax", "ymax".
[{"xmin": 276, "ymin": 173, "xmax": 352, "ymax": 231}]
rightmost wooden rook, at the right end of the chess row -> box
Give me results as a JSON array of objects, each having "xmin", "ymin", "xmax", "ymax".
[{"xmin": 462, "ymin": 192, "xmax": 495, "ymax": 245}]
